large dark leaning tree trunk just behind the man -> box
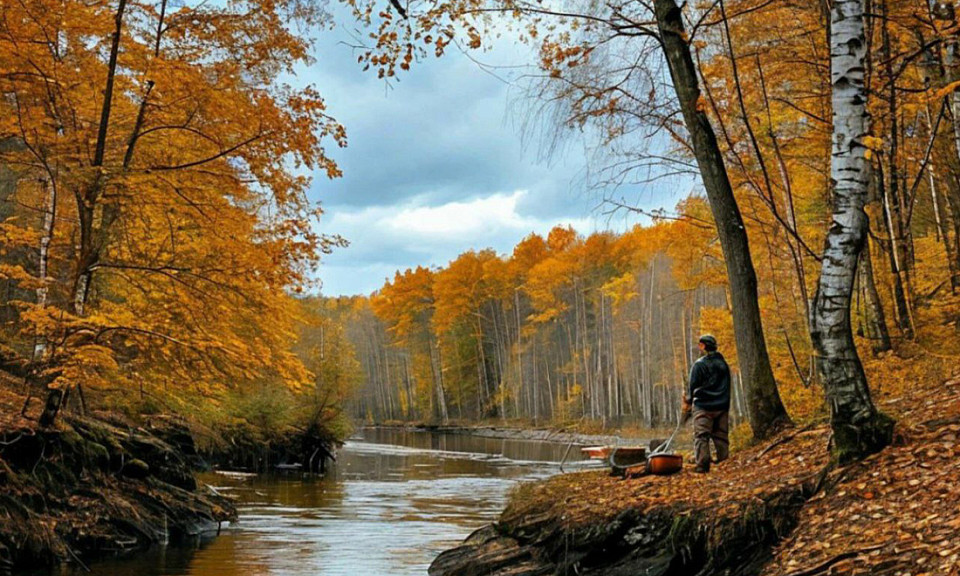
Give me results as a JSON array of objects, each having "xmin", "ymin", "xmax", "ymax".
[{"xmin": 654, "ymin": 0, "xmax": 789, "ymax": 439}]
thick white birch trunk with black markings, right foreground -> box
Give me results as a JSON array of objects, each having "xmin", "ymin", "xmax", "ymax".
[{"xmin": 810, "ymin": 0, "xmax": 893, "ymax": 463}]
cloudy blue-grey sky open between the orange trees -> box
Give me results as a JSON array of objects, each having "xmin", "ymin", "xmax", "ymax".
[{"xmin": 297, "ymin": 9, "xmax": 690, "ymax": 296}]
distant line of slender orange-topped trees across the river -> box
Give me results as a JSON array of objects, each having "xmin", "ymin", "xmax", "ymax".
[{"xmin": 343, "ymin": 218, "xmax": 739, "ymax": 427}]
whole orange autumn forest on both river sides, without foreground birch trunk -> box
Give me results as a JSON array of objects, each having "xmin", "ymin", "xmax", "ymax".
[{"xmin": 2, "ymin": 0, "xmax": 960, "ymax": 460}]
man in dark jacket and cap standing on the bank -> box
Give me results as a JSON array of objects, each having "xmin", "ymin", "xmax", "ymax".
[{"xmin": 683, "ymin": 334, "xmax": 730, "ymax": 473}]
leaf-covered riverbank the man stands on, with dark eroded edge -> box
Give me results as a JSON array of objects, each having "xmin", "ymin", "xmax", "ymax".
[{"xmin": 429, "ymin": 372, "xmax": 960, "ymax": 576}]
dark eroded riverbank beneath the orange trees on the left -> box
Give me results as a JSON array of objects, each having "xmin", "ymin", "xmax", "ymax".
[{"xmin": 0, "ymin": 390, "xmax": 236, "ymax": 570}]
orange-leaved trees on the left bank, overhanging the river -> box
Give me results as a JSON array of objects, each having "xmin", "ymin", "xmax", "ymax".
[{"xmin": 0, "ymin": 0, "xmax": 346, "ymax": 432}]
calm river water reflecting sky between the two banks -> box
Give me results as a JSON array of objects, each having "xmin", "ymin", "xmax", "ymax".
[{"xmin": 52, "ymin": 429, "xmax": 592, "ymax": 576}]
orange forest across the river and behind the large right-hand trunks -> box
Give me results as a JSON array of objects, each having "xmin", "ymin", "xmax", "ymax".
[{"xmin": 330, "ymin": 1, "xmax": 960, "ymax": 450}]
